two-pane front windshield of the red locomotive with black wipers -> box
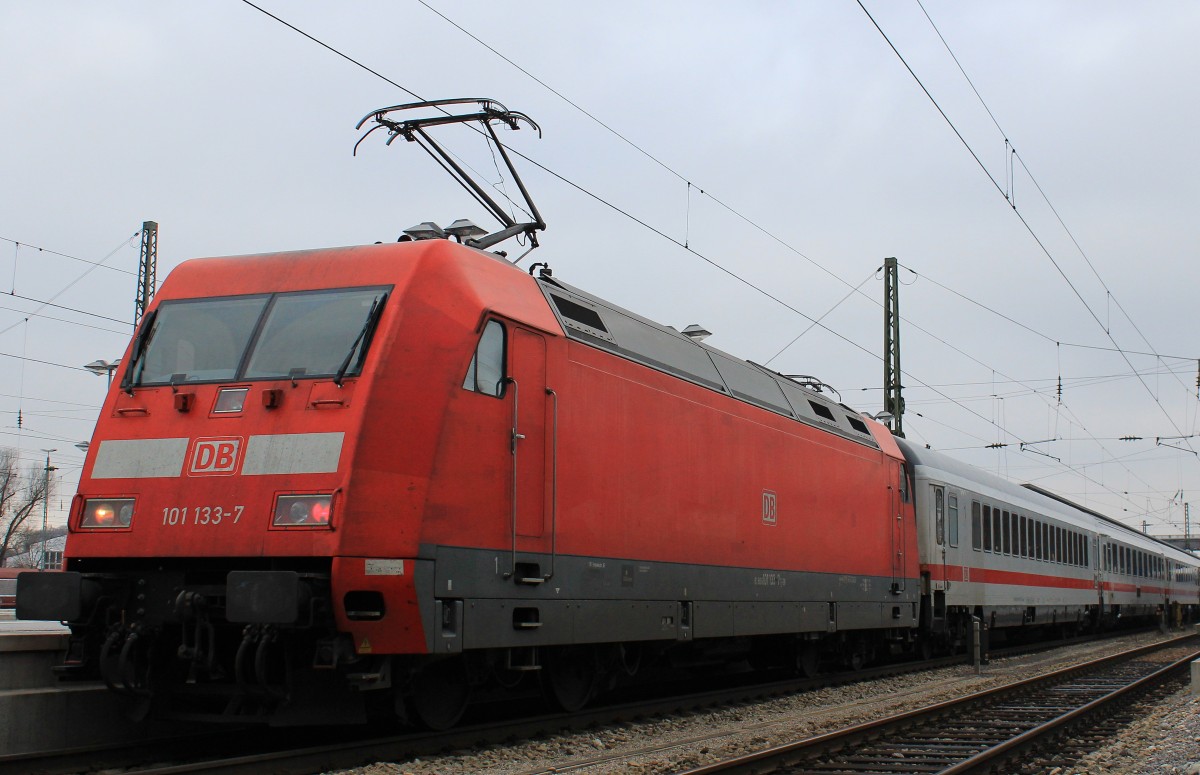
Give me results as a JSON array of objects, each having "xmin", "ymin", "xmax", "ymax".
[{"xmin": 132, "ymin": 288, "xmax": 386, "ymax": 385}]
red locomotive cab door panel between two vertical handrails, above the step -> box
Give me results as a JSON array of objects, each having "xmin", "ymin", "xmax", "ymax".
[{"xmin": 508, "ymin": 326, "xmax": 547, "ymax": 539}]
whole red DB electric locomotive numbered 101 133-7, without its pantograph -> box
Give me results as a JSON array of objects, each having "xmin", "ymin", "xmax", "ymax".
[{"xmin": 18, "ymin": 232, "xmax": 918, "ymax": 726}]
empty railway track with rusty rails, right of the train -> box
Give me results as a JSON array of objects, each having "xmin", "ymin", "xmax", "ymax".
[{"xmin": 684, "ymin": 638, "xmax": 1200, "ymax": 775}]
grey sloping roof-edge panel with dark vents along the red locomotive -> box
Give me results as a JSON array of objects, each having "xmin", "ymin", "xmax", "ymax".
[{"xmin": 538, "ymin": 276, "xmax": 887, "ymax": 451}]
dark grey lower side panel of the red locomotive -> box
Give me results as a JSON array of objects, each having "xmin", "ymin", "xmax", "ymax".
[{"xmin": 415, "ymin": 546, "xmax": 919, "ymax": 654}]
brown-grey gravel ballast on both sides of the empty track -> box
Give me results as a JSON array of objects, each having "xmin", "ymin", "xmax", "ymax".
[{"xmin": 328, "ymin": 633, "xmax": 1200, "ymax": 775}]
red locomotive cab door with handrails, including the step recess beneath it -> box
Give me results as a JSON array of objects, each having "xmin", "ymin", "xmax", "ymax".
[{"xmin": 508, "ymin": 326, "xmax": 557, "ymax": 583}]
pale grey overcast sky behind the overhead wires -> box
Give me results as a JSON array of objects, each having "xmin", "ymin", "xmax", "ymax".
[{"xmin": 0, "ymin": 0, "xmax": 1200, "ymax": 535}]
